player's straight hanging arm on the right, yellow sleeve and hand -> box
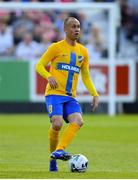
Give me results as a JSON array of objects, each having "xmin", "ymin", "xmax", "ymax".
[{"xmin": 81, "ymin": 50, "xmax": 99, "ymax": 111}]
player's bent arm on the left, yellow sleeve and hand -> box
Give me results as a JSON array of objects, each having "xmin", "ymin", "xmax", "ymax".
[{"xmin": 36, "ymin": 44, "xmax": 58, "ymax": 89}]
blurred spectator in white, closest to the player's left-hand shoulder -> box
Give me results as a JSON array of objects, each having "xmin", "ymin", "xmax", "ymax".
[{"xmin": 15, "ymin": 32, "xmax": 41, "ymax": 60}]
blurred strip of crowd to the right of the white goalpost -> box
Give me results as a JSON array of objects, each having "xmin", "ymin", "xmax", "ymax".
[{"xmin": 118, "ymin": 0, "xmax": 138, "ymax": 60}]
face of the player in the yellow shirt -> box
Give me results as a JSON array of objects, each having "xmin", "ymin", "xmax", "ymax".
[{"xmin": 65, "ymin": 19, "xmax": 80, "ymax": 41}]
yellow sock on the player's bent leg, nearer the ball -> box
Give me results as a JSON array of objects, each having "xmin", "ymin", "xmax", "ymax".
[{"xmin": 56, "ymin": 123, "xmax": 80, "ymax": 150}]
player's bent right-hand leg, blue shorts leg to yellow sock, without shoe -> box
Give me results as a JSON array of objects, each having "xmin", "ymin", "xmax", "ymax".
[{"xmin": 57, "ymin": 100, "xmax": 83, "ymax": 154}]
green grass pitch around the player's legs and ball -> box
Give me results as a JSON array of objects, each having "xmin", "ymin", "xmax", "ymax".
[{"xmin": 0, "ymin": 114, "xmax": 138, "ymax": 179}]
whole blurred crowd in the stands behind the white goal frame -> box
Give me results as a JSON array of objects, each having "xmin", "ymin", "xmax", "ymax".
[{"xmin": 0, "ymin": 0, "xmax": 138, "ymax": 60}]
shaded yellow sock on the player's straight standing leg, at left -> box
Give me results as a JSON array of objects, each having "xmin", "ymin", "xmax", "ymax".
[{"xmin": 49, "ymin": 127, "xmax": 59, "ymax": 152}]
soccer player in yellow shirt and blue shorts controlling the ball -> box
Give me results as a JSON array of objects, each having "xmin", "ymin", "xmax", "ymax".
[{"xmin": 36, "ymin": 17, "xmax": 99, "ymax": 171}]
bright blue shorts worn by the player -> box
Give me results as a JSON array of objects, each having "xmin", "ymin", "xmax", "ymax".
[{"xmin": 45, "ymin": 95, "xmax": 82, "ymax": 123}]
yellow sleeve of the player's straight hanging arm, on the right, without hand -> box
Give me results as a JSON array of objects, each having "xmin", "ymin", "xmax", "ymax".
[{"xmin": 81, "ymin": 48, "xmax": 99, "ymax": 96}]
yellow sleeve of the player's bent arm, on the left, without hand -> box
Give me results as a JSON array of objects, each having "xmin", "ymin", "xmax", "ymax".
[{"xmin": 36, "ymin": 44, "xmax": 55, "ymax": 79}]
